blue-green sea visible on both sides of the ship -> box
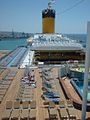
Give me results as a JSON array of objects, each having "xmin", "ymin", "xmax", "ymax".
[{"xmin": 0, "ymin": 34, "xmax": 87, "ymax": 50}]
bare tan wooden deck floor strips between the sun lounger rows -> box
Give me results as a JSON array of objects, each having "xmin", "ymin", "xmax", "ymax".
[{"xmin": 0, "ymin": 68, "xmax": 90, "ymax": 120}]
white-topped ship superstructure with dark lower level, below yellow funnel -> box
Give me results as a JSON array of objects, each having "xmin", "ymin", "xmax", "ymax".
[{"xmin": 27, "ymin": 34, "xmax": 85, "ymax": 64}]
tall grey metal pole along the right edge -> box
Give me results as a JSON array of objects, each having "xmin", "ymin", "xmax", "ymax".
[{"xmin": 82, "ymin": 22, "xmax": 90, "ymax": 120}]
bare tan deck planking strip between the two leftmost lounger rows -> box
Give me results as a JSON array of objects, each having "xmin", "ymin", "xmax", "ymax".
[{"xmin": 0, "ymin": 69, "xmax": 24, "ymax": 120}]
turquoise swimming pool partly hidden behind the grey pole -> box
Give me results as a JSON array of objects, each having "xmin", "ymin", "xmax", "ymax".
[{"xmin": 71, "ymin": 81, "xmax": 90, "ymax": 102}]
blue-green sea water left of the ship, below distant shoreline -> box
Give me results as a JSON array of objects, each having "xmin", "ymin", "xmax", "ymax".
[{"xmin": 0, "ymin": 38, "xmax": 27, "ymax": 50}]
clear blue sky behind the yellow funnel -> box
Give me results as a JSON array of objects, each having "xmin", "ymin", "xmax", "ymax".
[{"xmin": 0, "ymin": 0, "xmax": 90, "ymax": 34}]
